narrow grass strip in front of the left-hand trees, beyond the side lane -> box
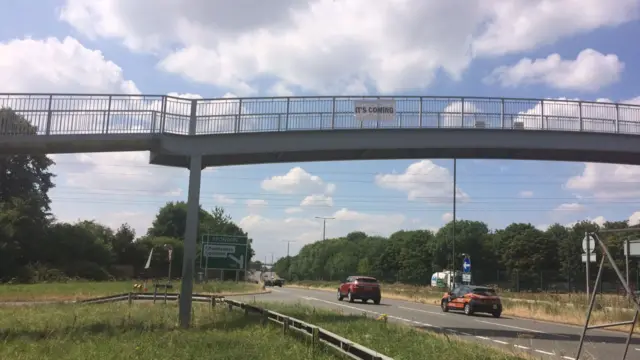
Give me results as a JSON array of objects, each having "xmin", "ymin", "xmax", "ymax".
[{"xmin": 0, "ymin": 281, "xmax": 262, "ymax": 302}]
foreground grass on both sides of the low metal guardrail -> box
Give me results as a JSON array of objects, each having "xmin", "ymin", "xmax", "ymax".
[{"xmin": 0, "ymin": 303, "xmax": 523, "ymax": 360}]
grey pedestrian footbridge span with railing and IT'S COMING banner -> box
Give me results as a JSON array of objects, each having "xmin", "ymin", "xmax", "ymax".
[{"xmin": 0, "ymin": 94, "xmax": 640, "ymax": 168}]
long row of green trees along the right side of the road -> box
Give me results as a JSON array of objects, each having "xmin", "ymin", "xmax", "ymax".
[{"xmin": 274, "ymin": 220, "xmax": 640, "ymax": 291}]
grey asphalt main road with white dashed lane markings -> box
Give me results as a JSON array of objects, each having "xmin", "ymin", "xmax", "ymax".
[{"xmin": 229, "ymin": 287, "xmax": 640, "ymax": 360}]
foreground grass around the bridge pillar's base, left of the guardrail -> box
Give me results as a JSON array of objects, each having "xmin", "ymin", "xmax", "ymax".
[{"xmin": 0, "ymin": 303, "xmax": 339, "ymax": 360}]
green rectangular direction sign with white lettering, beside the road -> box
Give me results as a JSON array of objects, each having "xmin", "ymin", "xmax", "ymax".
[{"xmin": 200, "ymin": 235, "xmax": 249, "ymax": 270}]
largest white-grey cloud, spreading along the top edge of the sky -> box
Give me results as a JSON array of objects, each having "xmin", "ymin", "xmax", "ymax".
[{"xmin": 61, "ymin": 0, "xmax": 638, "ymax": 94}]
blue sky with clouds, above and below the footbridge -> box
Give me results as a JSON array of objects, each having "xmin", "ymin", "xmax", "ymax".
[{"xmin": 0, "ymin": 0, "xmax": 640, "ymax": 259}]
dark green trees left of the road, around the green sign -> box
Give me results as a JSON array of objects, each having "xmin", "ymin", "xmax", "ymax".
[{"xmin": 0, "ymin": 109, "xmax": 254, "ymax": 282}]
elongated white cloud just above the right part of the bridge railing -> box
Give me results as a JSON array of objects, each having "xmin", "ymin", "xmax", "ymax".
[{"xmin": 485, "ymin": 49, "xmax": 625, "ymax": 92}]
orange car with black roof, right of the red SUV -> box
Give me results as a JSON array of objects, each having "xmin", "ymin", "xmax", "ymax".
[{"xmin": 440, "ymin": 285, "xmax": 502, "ymax": 318}]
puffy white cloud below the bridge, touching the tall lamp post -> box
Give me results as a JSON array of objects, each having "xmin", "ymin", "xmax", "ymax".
[{"xmin": 375, "ymin": 160, "xmax": 469, "ymax": 203}]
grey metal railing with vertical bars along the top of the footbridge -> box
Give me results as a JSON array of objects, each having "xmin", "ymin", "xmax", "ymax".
[{"xmin": 0, "ymin": 94, "xmax": 640, "ymax": 136}]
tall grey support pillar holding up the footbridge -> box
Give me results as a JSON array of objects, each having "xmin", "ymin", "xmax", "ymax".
[{"xmin": 179, "ymin": 155, "xmax": 202, "ymax": 328}]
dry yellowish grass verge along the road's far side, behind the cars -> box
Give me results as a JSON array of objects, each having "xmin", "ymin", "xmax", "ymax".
[{"xmin": 287, "ymin": 281, "xmax": 640, "ymax": 333}]
